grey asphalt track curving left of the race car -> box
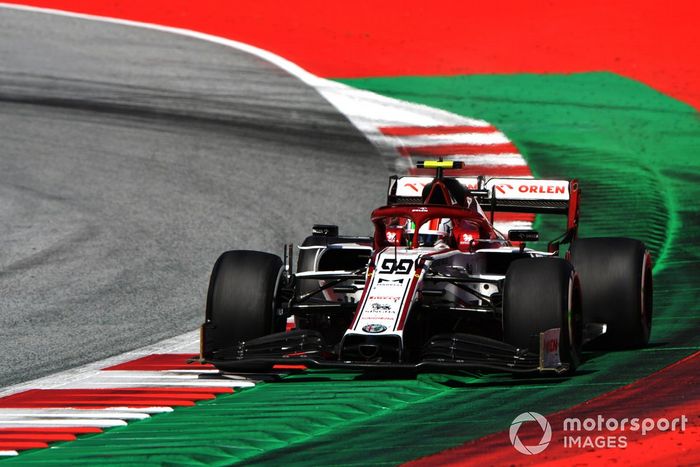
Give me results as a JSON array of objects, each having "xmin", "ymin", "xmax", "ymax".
[{"xmin": 0, "ymin": 9, "xmax": 388, "ymax": 387}]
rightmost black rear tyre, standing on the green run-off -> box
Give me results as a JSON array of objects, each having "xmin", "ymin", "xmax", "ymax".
[{"xmin": 570, "ymin": 238, "xmax": 654, "ymax": 349}]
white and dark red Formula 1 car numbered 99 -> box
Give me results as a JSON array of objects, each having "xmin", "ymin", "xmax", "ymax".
[{"xmin": 201, "ymin": 160, "xmax": 652, "ymax": 373}]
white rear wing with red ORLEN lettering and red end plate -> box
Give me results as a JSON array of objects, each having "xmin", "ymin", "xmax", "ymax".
[{"xmin": 387, "ymin": 175, "xmax": 581, "ymax": 243}]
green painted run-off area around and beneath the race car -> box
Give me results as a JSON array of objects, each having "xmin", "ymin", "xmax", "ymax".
[{"xmin": 4, "ymin": 73, "xmax": 700, "ymax": 465}]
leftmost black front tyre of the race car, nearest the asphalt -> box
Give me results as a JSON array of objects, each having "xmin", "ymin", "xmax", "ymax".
[{"xmin": 202, "ymin": 250, "xmax": 284, "ymax": 358}]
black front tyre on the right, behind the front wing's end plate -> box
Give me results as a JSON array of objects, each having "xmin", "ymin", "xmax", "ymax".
[{"xmin": 503, "ymin": 258, "xmax": 583, "ymax": 370}]
